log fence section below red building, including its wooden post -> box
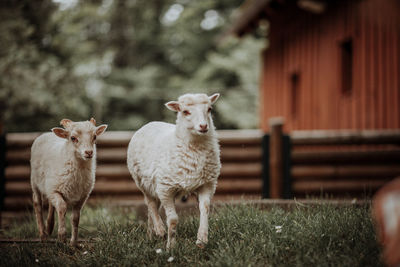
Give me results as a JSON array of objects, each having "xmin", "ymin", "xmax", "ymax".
[{"xmin": 263, "ymin": 119, "xmax": 400, "ymax": 198}]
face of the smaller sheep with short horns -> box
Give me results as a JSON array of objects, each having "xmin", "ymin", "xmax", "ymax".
[{"xmin": 51, "ymin": 118, "xmax": 107, "ymax": 160}]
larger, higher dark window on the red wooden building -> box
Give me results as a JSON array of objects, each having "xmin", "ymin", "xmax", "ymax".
[{"xmin": 340, "ymin": 39, "xmax": 353, "ymax": 95}]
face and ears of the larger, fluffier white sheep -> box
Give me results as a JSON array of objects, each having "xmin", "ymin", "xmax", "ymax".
[{"xmin": 166, "ymin": 94, "xmax": 219, "ymax": 135}]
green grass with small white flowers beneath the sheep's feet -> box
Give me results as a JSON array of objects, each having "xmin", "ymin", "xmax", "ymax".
[{"xmin": 0, "ymin": 205, "xmax": 382, "ymax": 266}]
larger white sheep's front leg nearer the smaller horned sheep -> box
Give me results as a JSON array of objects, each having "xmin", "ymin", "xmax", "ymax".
[{"xmin": 159, "ymin": 192, "xmax": 178, "ymax": 249}]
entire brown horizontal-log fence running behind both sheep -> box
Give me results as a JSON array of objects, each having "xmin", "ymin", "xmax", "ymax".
[{"xmin": 0, "ymin": 126, "xmax": 400, "ymax": 226}]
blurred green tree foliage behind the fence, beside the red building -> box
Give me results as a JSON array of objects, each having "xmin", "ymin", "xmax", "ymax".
[{"xmin": 0, "ymin": 0, "xmax": 264, "ymax": 131}]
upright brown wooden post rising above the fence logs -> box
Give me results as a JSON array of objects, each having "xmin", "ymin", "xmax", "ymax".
[{"xmin": 269, "ymin": 117, "xmax": 284, "ymax": 198}]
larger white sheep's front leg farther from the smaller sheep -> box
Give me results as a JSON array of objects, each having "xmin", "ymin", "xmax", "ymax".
[{"xmin": 196, "ymin": 185, "xmax": 214, "ymax": 248}]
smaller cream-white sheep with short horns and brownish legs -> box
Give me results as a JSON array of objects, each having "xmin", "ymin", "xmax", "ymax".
[{"xmin": 31, "ymin": 118, "xmax": 107, "ymax": 246}]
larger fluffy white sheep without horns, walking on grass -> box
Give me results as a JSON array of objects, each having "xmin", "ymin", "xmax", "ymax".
[{"xmin": 127, "ymin": 94, "xmax": 221, "ymax": 248}]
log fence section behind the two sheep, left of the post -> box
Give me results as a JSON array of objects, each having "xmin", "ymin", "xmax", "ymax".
[{"xmin": 0, "ymin": 130, "xmax": 262, "ymax": 223}]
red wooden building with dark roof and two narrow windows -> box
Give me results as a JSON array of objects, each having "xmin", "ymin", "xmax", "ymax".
[{"xmin": 232, "ymin": 0, "xmax": 400, "ymax": 131}]
